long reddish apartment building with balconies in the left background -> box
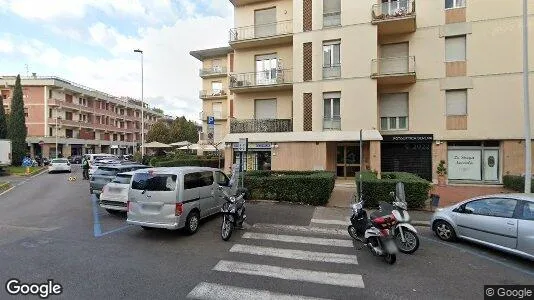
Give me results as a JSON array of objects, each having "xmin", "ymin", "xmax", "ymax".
[{"xmin": 0, "ymin": 76, "xmax": 164, "ymax": 157}]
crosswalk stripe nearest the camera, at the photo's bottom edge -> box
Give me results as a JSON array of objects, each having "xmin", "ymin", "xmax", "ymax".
[{"xmin": 187, "ymin": 282, "xmax": 326, "ymax": 300}]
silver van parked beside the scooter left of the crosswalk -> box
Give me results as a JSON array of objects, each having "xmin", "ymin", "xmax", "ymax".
[{"xmin": 127, "ymin": 167, "xmax": 230, "ymax": 234}]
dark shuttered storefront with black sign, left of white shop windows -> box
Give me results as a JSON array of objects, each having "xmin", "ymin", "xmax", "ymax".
[{"xmin": 380, "ymin": 134, "xmax": 434, "ymax": 180}]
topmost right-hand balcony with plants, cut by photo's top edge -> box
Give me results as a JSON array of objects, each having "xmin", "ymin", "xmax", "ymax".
[{"xmin": 372, "ymin": 0, "xmax": 416, "ymax": 35}]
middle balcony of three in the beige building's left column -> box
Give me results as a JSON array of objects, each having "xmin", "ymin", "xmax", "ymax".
[{"xmin": 230, "ymin": 69, "xmax": 293, "ymax": 93}]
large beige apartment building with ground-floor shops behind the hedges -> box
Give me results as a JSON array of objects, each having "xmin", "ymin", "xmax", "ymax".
[{"xmin": 197, "ymin": 0, "xmax": 534, "ymax": 184}]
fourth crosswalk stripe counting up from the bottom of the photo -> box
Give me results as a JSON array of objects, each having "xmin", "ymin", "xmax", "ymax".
[{"xmin": 243, "ymin": 232, "xmax": 354, "ymax": 248}]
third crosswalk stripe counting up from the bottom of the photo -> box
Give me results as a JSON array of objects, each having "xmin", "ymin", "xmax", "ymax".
[{"xmin": 230, "ymin": 244, "xmax": 358, "ymax": 265}]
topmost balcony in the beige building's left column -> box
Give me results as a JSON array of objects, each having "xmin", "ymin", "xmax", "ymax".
[{"xmin": 229, "ymin": 20, "xmax": 293, "ymax": 49}]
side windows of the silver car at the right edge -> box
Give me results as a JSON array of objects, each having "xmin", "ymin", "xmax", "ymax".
[{"xmin": 464, "ymin": 198, "xmax": 517, "ymax": 218}]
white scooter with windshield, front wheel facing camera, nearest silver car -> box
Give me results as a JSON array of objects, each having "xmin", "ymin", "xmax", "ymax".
[{"xmin": 390, "ymin": 182, "xmax": 419, "ymax": 254}]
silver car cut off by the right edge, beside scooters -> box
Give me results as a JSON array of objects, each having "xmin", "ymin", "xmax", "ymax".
[{"xmin": 431, "ymin": 194, "xmax": 534, "ymax": 260}]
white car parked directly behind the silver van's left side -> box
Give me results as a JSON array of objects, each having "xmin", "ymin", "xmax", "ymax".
[{"xmin": 99, "ymin": 172, "xmax": 134, "ymax": 214}]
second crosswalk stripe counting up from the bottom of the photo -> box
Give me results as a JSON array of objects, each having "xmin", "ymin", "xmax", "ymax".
[{"xmin": 213, "ymin": 260, "xmax": 365, "ymax": 288}]
